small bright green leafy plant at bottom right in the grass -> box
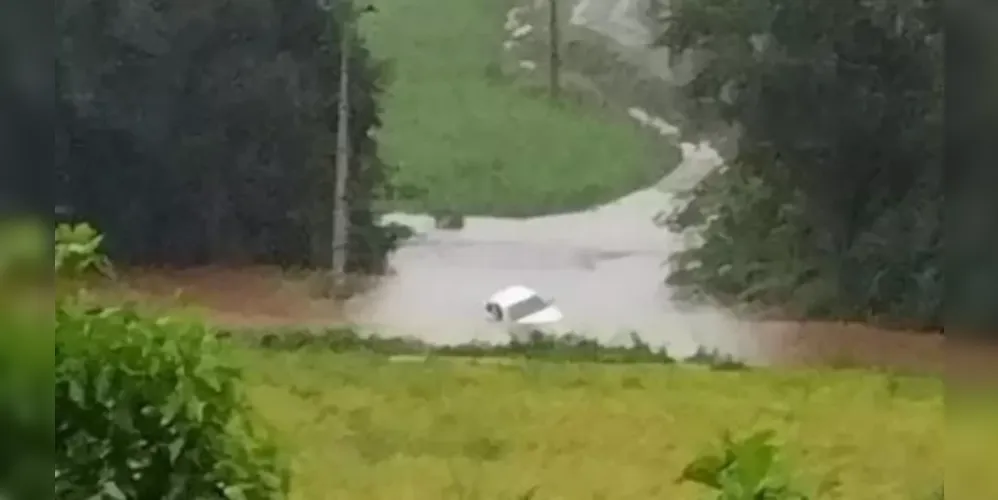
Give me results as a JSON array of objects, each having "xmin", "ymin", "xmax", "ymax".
[{"xmin": 679, "ymin": 431, "xmax": 810, "ymax": 500}]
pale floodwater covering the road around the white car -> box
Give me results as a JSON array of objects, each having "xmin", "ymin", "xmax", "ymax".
[{"xmin": 347, "ymin": 143, "xmax": 776, "ymax": 358}]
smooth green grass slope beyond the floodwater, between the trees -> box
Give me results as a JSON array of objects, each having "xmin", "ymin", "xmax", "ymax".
[{"xmin": 363, "ymin": 0, "xmax": 675, "ymax": 216}]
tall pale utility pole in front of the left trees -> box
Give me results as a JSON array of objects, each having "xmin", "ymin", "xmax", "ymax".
[{"xmin": 330, "ymin": 6, "xmax": 354, "ymax": 294}]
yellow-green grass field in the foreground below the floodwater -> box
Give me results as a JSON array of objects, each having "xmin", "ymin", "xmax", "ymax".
[{"xmin": 244, "ymin": 350, "xmax": 944, "ymax": 500}]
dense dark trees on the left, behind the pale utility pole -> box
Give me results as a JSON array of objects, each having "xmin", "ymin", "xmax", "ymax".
[{"xmin": 55, "ymin": 0, "xmax": 402, "ymax": 269}]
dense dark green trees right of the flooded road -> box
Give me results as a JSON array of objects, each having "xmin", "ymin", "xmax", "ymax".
[{"xmin": 661, "ymin": 0, "xmax": 944, "ymax": 330}]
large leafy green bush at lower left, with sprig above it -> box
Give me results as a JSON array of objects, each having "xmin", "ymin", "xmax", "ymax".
[{"xmin": 50, "ymin": 226, "xmax": 288, "ymax": 500}]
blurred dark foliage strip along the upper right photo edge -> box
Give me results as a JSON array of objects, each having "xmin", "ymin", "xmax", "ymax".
[{"xmin": 946, "ymin": 1, "xmax": 998, "ymax": 335}]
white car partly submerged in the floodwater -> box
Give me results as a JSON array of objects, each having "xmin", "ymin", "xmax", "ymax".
[{"xmin": 485, "ymin": 285, "xmax": 568, "ymax": 342}]
